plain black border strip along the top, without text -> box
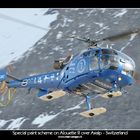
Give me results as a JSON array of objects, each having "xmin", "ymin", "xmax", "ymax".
[{"xmin": 0, "ymin": 0, "xmax": 140, "ymax": 8}]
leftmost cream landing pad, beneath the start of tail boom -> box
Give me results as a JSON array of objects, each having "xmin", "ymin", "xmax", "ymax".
[{"xmin": 40, "ymin": 90, "xmax": 66, "ymax": 101}]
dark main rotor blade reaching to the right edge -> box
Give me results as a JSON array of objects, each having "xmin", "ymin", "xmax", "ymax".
[{"xmin": 95, "ymin": 28, "xmax": 140, "ymax": 43}]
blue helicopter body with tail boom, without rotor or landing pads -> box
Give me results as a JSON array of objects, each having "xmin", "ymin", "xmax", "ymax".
[{"xmin": 8, "ymin": 48, "xmax": 135, "ymax": 93}]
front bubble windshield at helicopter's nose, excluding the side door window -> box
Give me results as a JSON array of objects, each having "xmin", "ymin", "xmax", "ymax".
[{"xmin": 100, "ymin": 49, "xmax": 135, "ymax": 76}]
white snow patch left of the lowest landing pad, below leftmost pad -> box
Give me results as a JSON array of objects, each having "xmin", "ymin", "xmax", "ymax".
[{"xmin": 32, "ymin": 112, "xmax": 60, "ymax": 127}]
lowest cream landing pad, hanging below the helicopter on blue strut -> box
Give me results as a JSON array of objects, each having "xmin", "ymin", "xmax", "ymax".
[{"xmin": 80, "ymin": 107, "xmax": 107, "ymax": 118}]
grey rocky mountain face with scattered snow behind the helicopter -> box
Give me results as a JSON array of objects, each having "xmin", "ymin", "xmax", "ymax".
[{"xmin": 0, "ymin": 8, "xmax": 140, "ymax": 129}]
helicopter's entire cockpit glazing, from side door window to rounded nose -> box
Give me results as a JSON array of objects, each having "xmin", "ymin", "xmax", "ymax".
[{"xmin": 89, "ymin": 48, "xmax": 135, "ymax": 76}]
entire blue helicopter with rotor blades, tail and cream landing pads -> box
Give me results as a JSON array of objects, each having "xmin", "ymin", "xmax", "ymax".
[{"xmin": 0, "ymin": 29, "xmax": 140, "ymax": 118}]
